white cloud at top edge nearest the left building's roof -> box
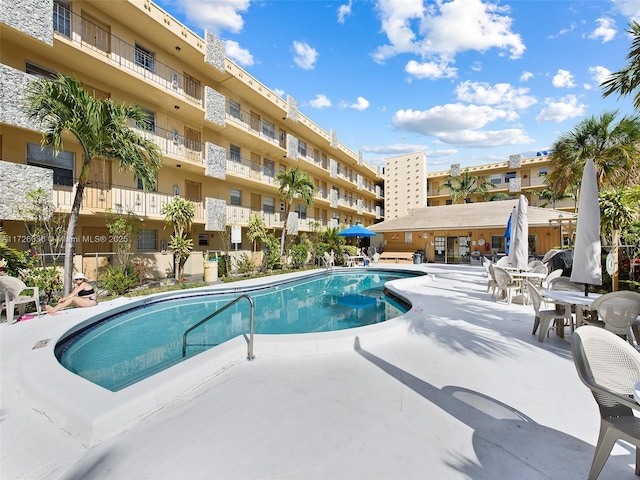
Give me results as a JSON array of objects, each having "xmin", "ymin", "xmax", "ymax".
[{"xmin": 175, "ymin": 0, "xmax": 251, "ymax": 33}]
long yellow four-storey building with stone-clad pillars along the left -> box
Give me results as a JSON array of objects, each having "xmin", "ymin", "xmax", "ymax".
[{"xmin": 0, "ymin": 0, "xmax": 383, "ymax": 273}]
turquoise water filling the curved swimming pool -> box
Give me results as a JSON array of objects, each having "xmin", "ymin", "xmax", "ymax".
[{"xmin": 56, "ymin": 269, "xmax": 416, "ymax": 391}]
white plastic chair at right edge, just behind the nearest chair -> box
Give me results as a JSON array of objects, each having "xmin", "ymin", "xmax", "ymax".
[{"xmin": 590, "ymin": 291, "xmax": 640, "ymax": 344}]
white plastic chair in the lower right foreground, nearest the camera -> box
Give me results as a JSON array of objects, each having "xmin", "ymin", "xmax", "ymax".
[{"xmin": 571, "ymin": 325, "xmax": 640, "ymax": 480}]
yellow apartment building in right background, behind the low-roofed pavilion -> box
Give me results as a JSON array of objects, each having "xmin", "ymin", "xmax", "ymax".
[{"xmin": 424, "ymin": 152, "xmax": 576, "ymax": 212}]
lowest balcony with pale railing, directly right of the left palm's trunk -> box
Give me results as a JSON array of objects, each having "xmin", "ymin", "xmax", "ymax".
[{"xmin": 52, "ymin": 182, "xmax": 204, "ymax": 222}]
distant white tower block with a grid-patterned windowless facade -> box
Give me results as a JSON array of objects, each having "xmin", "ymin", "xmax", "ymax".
[{"xmin": 384, "ymin": 152, "xmax": 427, "ymax": 220}]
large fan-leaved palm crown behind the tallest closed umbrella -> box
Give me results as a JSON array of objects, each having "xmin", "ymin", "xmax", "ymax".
[{"xmin": 549, "ymin": 111, "xmax": 640, "ymax": 194}]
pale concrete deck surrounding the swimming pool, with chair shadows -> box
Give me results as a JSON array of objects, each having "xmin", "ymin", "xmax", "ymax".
[{"xmin": 0, "ymin": 264, "xmax": 636, "ymax": 480}]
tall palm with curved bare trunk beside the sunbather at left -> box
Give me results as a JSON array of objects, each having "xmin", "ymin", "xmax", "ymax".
[{"xmin": 25, "ymin": 75, "xmax": 162, "ymax": 294}]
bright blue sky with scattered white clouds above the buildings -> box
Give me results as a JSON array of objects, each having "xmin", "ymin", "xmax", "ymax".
[{"xmin": 157, "ymin": 0, "xmax": 640, "ymax": 171}]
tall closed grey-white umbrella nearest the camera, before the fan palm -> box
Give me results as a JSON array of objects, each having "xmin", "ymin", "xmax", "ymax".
[{"xmin": 571, "ymin": 159, "xmax": 602, "ymax": 296}]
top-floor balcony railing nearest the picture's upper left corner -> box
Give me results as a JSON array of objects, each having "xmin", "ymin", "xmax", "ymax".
[{"xmin": 53, "ymin": 3, "xmax": 202, "ymax": 105}]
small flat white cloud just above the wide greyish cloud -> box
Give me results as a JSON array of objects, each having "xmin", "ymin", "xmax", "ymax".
[{"xmin": 455, "ymin": 81, "xmax": 538, "ymax": 110}]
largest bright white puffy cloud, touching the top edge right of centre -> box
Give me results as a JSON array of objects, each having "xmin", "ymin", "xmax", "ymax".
[{"xmin": 374, "ymin": 0, "xmax": 526, "ymax": 63}]
